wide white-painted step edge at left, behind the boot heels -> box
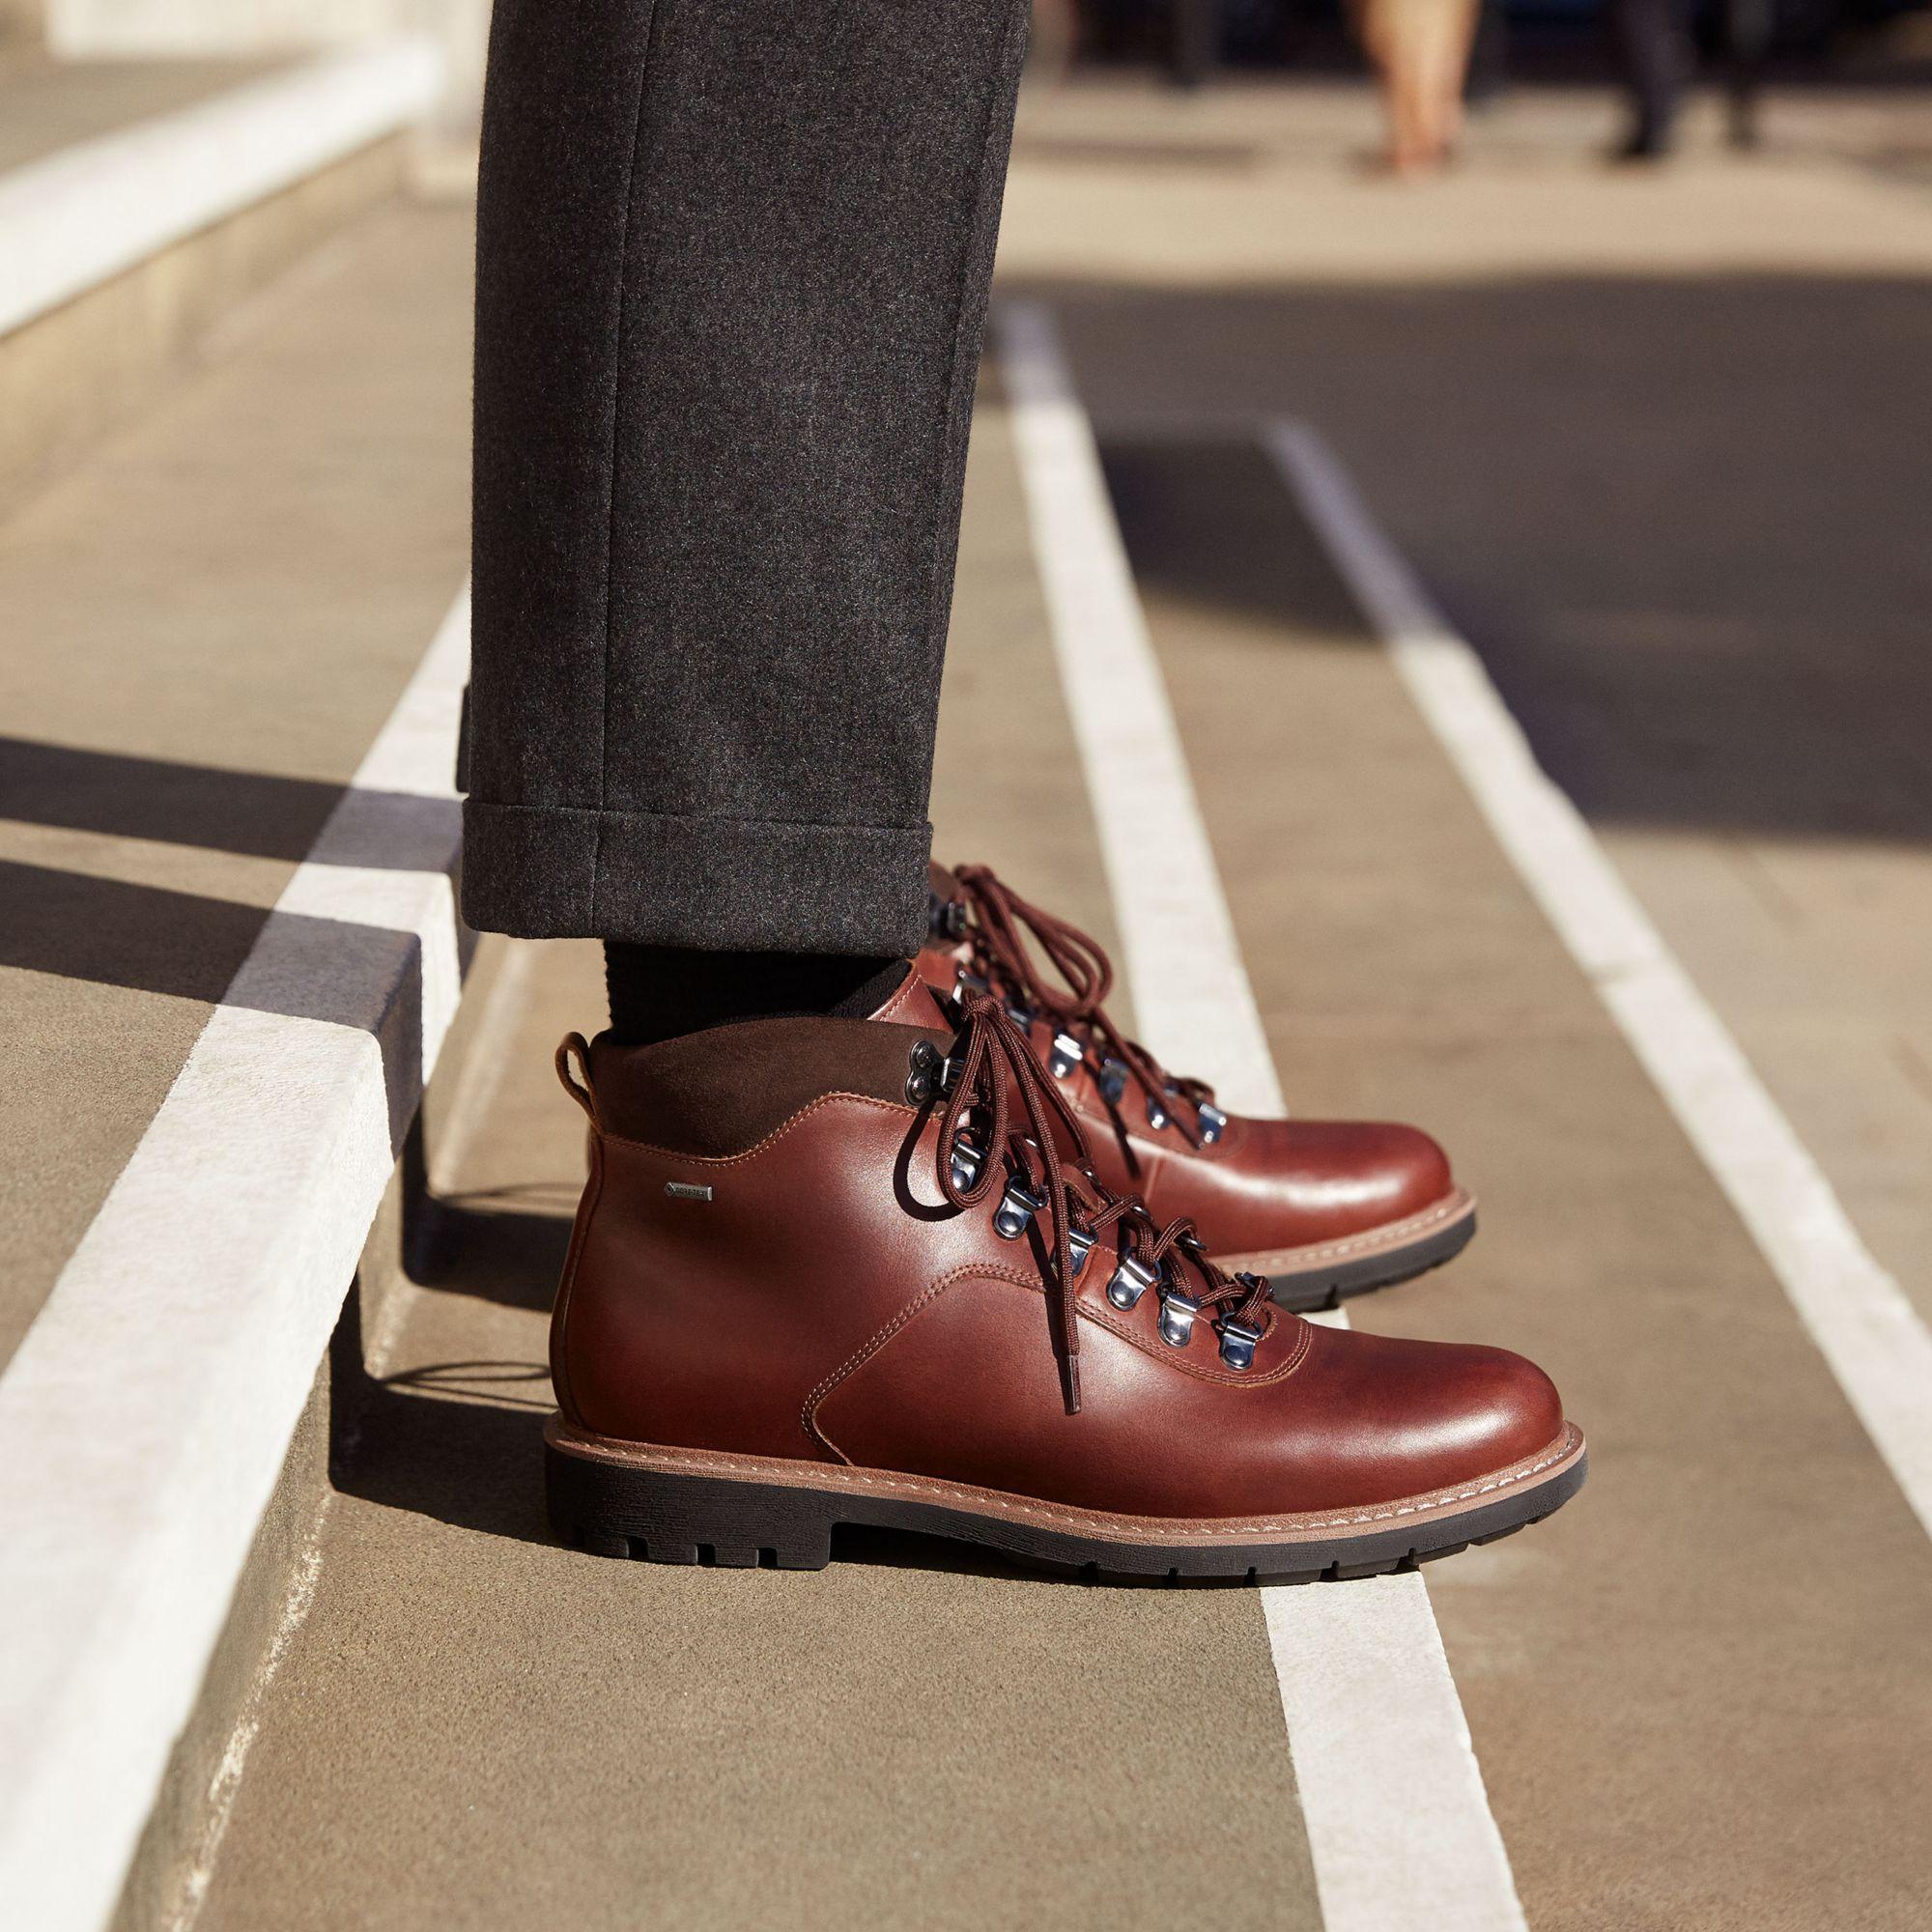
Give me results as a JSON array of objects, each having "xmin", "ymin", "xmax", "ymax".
[{"xmin": 0, "ymin": 595, "xmax": 469, "ymax": 1932}]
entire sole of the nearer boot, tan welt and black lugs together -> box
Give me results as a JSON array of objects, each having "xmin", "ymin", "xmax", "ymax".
[{"xmin": 545, "ymin": 1416, "xmax": 1588, "ymax": 1582}]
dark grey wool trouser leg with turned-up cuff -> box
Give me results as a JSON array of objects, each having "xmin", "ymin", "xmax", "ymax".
[{"xmin": 464, "ymin": 0, "xmax": 1028, "ymax": 956}]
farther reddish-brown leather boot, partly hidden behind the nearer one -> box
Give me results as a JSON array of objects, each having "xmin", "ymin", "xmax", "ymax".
[{"xmin": 918, "ymin": 866, "xmax": 1476, "ymax": 1308}]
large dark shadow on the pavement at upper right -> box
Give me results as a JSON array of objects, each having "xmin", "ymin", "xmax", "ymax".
[{"xmin": 1024, "ymin": 274, "xmax": 1932, "ymax": 844}]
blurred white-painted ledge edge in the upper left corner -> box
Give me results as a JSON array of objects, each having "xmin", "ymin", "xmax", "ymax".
[{"xmin": 0, "ymin": 35, "xmax": 442, "ymax": 334}]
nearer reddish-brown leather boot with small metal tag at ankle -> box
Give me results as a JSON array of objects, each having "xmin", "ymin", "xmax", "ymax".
[{"xmin": 549, "ymin": 976, "xmax": 1584, "ymax": 1577}]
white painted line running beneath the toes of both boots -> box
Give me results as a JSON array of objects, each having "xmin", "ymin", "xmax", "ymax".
[{"xmin": 999, "ymin": 303, "xmax": 1522, "ymax": 1932}]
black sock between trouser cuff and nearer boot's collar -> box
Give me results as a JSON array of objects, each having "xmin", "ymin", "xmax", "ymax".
[{"xmin": 605, "ymin": 941, "xmax": 912, "ymax": 1047}]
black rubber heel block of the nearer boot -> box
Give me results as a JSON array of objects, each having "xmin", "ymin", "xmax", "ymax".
[{"xmin": 545, "ymin": 1443, "xmax": 833, "ymax": 1569}]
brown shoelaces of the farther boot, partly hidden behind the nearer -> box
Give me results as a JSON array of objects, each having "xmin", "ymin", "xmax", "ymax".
[{"xmin": 954, "ymin": 866, "xmax": 1213, "ymax": 1161}]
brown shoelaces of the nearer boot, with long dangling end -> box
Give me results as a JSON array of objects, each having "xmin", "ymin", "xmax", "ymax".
[{"xmin": 939, "ymin": 997, "xmax": 1273, "ymax": 1414}]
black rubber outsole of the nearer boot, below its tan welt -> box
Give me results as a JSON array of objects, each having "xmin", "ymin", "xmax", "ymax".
[{"xmin": 545, "ymin": 1443, "xmax": 1588, "ymax": 1582}]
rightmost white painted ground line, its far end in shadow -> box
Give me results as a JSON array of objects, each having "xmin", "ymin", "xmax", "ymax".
[{"xmin": 1264, "ymin": 421, "xmax": 1932, "ymax": 1534}]
